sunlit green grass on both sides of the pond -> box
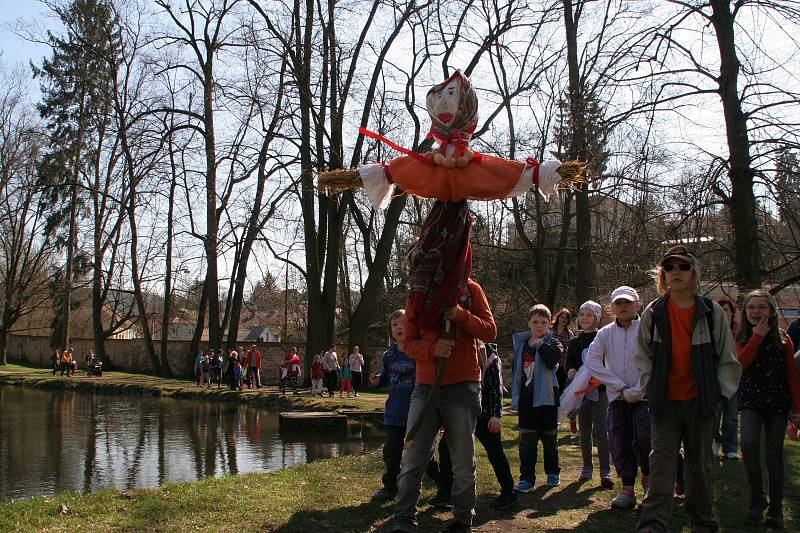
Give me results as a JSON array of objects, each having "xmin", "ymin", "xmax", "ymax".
[{"xmin": 0, "ymin": 365, "xmax": 800, "ymax": 533}]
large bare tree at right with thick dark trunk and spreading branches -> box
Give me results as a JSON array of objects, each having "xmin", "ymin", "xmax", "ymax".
[{"xmin": 631, "ymin": 0, "xmax": 800, "ymax": 292}]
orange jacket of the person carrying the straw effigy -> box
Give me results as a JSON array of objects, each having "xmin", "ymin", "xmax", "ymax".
[{"xmin": 403, "ymin": 279, "xmax": 497, "ymax": 385}]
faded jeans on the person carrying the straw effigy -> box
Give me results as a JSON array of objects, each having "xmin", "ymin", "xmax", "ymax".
[{"xmin": 393, "ymin": 381, "xmax": 481, "ymax": 532}]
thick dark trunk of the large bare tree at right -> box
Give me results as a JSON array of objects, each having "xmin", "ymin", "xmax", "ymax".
[{"xmin": 711, "ymin": 0, "xmax": 762, "ymax": 294}]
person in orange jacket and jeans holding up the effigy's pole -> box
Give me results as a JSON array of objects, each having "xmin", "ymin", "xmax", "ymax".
[{"xmin": 393, "ymin": 278, "xmax": 497, "ymax": 532}]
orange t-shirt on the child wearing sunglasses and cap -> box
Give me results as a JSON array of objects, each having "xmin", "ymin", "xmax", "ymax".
[{"xmin": 667, "ymin": 299, "xmax": 698, "ymax": 400}]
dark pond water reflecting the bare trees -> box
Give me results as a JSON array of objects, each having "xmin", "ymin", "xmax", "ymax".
[{"xmin": 0, "ymin": 387, "xmax": 383, "ymax": 500}]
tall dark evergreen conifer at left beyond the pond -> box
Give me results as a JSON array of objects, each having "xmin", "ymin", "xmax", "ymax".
[{"xmin": 32, "ymin": 0, "xmax": 120, "ymax": 346}]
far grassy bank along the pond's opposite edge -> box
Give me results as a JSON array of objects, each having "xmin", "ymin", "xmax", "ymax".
[{"xmin": 0, "ymin": 364, "xmax": 386, "ymax": 411}]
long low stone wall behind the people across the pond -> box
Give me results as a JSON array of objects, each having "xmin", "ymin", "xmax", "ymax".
[{"xmin": 8, "ymin": 335, "xmax": 511, "ymax": 387}]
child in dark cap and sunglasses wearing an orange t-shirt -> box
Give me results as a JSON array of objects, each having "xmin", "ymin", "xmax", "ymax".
[{"xmin": 636, "ymin": 246, "xmax": 742, "ymax": 532}]
